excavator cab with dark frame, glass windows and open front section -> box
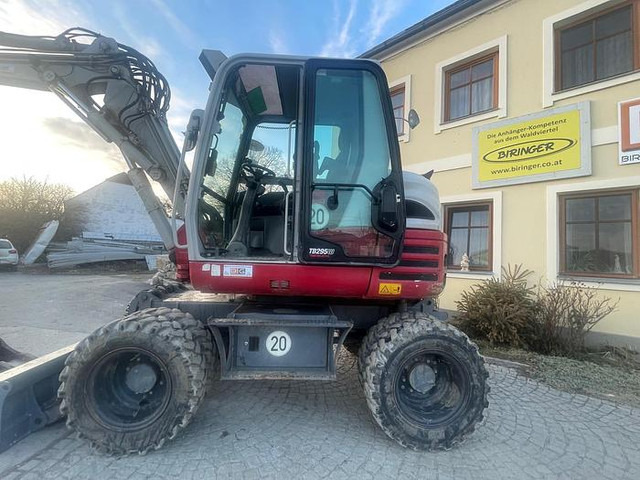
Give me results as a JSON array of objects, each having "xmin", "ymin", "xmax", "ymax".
[{"xmin": 187, "ymin": 57, "xmax": 405, "ymax": 266}]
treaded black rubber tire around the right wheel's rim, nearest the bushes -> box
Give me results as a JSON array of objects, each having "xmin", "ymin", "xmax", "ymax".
[{"xmin": 358, "ymin": 312, "xmax": 489, "ymax": 450}]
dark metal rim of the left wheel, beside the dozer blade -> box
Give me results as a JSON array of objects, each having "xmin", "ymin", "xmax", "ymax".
[{"xmin": 85, "ymin": 347, "xmax": 172, "ymax": 431}]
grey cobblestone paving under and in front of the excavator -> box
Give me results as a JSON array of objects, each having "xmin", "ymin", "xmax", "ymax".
[{"xmin": 0, "ymin": 356, "xmax": 640, "ymax": 480}]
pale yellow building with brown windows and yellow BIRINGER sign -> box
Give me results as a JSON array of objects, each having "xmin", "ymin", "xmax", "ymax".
[{"xmin": 362, "ymin": 0, "xmax": 640, "ymax": 346}]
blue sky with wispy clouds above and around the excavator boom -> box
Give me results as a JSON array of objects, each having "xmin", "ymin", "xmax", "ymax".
[{"xmin": 0, "ymin": 0, "xmax": 453, "ymax": 192}]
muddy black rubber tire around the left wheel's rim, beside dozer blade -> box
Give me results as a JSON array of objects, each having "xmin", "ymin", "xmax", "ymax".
[{"xmin": 58, "ymin": 308, "xmax": 211, "ymax": 455}]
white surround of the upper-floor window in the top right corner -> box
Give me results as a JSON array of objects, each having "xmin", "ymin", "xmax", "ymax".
[{"xmin": 542, "ymin": 0, "xmax": 640, "ymax": 108}]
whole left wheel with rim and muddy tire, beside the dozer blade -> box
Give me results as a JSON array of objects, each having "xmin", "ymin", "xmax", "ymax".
[{"xmin": 58, "ymin": 308, "xmax": 211, "ymax": 455}]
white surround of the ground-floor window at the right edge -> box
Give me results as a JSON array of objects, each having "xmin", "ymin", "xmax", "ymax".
[{"xmin": 546, "ymin": 177, "xmax": 640, "ymax": 292}]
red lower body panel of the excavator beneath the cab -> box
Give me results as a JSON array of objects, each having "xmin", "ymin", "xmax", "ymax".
[{"xmin": 185, "ymin": 230, "xmax": 447, "ymax": 300}]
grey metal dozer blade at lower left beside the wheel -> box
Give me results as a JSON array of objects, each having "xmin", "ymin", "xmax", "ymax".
[{"xmin": 0, "ymin": 344, "xmax": 75, "ymax": 452}]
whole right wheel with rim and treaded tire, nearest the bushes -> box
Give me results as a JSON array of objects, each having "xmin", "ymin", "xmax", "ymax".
[{"xmin": 359, "ymin": 312, "xmax": 489, "ymax": 450}]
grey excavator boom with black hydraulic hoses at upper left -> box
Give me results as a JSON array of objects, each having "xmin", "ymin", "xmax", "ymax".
[{"xmin": 0, "ymin": 28, "xmax": 188, "ymax": 248}]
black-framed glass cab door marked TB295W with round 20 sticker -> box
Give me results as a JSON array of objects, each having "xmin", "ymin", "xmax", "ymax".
[{"xmin": 299, "ymin": 59, "xmax": 405, "ymax": 265}]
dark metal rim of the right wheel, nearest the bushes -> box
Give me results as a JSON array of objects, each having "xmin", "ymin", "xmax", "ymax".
[{"xmin": 393, "ymin": 350, "xmax": 471, "ymax": 428}]
